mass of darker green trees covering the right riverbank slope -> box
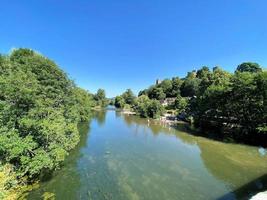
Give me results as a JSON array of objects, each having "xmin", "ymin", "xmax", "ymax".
[{"xmin": 114, "ymin": 62, "xmax": 267, "ymax": 143}]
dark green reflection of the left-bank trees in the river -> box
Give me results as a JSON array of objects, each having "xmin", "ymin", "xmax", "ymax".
[{"xmin": 28, "ymin": 122, "xmax": 90, "ymax": 200}]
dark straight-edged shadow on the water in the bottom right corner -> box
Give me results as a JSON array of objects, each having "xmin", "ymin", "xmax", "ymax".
[{"xmin": 217, "ymin": 174, "xmax": 267, "ymax": 200}]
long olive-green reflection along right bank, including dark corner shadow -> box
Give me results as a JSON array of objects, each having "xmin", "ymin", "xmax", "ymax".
[{"xmin": 121, "ymin": 114, "xmax": 267, "ymax": 200}]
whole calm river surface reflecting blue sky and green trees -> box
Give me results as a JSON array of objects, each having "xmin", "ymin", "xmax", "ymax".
[{"xmin": 29, "ymin": 111, "xmax": 267, "ymax": 200}]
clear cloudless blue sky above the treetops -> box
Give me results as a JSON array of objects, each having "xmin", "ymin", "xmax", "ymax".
[{"xmin": 0, "ymin": 0, "xmax": 267, "ymax": 97}]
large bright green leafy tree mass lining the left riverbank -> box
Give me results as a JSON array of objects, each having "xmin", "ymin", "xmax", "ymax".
[{"xmin": 0, "ymin": 49, "xmax": 107, "ymax": 199}]
